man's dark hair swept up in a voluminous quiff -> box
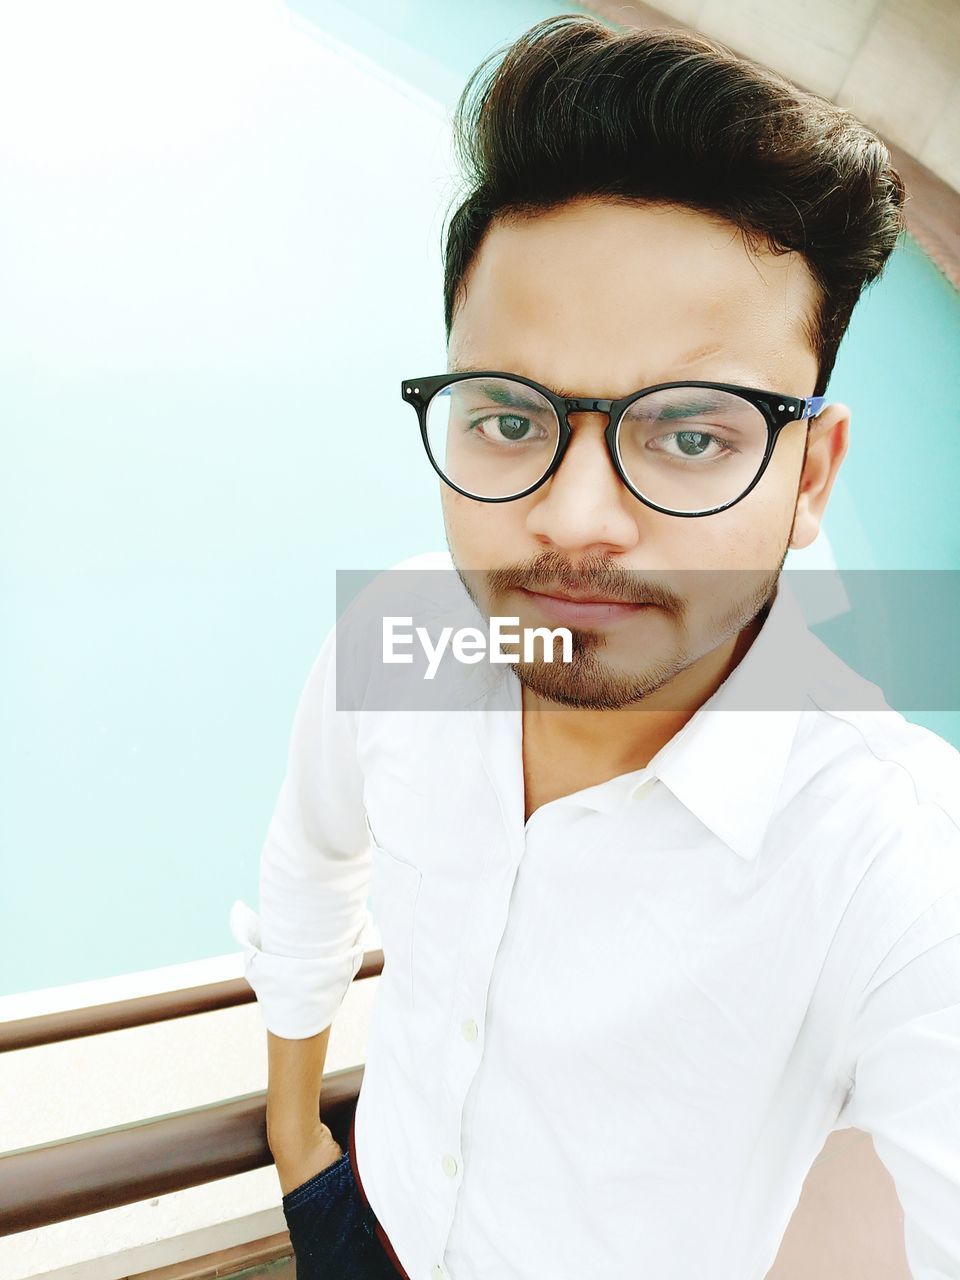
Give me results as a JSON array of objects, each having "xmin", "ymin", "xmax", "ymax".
[{"xmin": 444, "ymin": 14, "xmax": 905, "ymax": 396}]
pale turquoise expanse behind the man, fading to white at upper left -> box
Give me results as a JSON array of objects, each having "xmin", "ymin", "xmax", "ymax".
[{"xmin": 0, "ymin": 0, "xmax": 960, "ymax": 993}]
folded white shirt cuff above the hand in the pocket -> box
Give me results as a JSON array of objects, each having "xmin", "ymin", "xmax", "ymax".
[{"xmin": 230, "ymin": 899, "xmax": 370, "ymax": 1039}]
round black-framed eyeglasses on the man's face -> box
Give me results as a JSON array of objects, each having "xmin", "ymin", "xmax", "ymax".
[{"xmin": 401, "ymin": 370, "xmax": 826, "ymax": 516}]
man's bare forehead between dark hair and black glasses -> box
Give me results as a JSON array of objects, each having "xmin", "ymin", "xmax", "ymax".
[{"xmin": 448, "ymin": 204, "xmax": 817, "ymax": 396}]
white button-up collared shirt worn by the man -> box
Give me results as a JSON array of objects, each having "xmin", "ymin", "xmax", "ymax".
[{"xmin": 232, "ymin": 557, "xmax": 960, "ymax": 1280}]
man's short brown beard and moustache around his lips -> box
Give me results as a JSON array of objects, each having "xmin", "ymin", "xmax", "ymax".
[{"xmin": 456, "ymin": 548, "xmax": 786, "ymax": 710}]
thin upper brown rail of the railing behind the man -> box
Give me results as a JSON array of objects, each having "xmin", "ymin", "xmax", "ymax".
[{"xmin": 0, "ymin": 948, "xmax": 383, "ymax": 1053}]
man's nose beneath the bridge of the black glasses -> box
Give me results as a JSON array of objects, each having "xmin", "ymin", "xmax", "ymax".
[{"xmin": 527, "ymin": 411, "xmax": 640, "ymax": 552}]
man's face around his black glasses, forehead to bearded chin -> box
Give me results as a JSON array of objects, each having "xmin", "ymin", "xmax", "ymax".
[{"xmin": 442, "ymin": 200, "xmax": 845, "ymax": 709}]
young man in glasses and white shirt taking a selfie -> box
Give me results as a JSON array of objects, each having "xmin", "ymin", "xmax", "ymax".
[{"xmin": 234, "ymin": 15, "xmax": 960, "ymax": 1280}]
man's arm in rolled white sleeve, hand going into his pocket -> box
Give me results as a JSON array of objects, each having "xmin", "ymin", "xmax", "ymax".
[{"xmin": 230, "ymin": 619, "xmax": 370, "ymax": 1192}]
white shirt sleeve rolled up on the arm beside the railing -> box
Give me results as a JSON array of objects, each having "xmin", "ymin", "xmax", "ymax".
[{"xmin": 229, "ymin": 628, "xmax": 371, "ymax": 1039}]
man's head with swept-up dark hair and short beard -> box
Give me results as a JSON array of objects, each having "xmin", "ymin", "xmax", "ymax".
[{"xmin": 432, "ymin": 15, "xmax": 904, "ymax": 709}]
